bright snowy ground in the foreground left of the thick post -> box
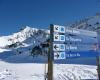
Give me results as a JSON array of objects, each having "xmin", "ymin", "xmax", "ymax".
[{"xmin": 0, "ymin": 62, "xmax": 44, "ymax": 80}]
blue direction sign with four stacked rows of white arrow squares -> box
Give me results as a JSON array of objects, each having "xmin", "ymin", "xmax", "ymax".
[{"xmin": 52, "ymin": 25, "xmax": 99, "ymax": 60}]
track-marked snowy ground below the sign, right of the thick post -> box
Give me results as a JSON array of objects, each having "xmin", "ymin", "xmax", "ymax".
[{"xmin": 54, "ymin": 64, "xmax": 97, "ymax": 80}]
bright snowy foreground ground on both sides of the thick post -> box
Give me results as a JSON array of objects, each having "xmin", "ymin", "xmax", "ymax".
[{"xmin": 0, "ymin": 61, "xmax": 97, "ymax": 80}]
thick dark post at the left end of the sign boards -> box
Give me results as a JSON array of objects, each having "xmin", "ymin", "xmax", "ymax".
[{"xmin": 48, "ymin": 25, "xmax": 53, "ymax": 80}]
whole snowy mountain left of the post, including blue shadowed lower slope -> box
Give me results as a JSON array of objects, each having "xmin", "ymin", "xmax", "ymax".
[{"xmin": 0, "ymin": 26, "xmax": 49, "ymax": 63}]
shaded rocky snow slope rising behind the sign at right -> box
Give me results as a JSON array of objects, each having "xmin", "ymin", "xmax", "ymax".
[{"xmin": 68, "ymin": 13, "xmax": 100, "ymax": 31}]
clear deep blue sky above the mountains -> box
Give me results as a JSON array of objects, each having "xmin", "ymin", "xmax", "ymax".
[{"xmin": 0, "ymin": 0, "xmax": 100, "ymax": 36}]
